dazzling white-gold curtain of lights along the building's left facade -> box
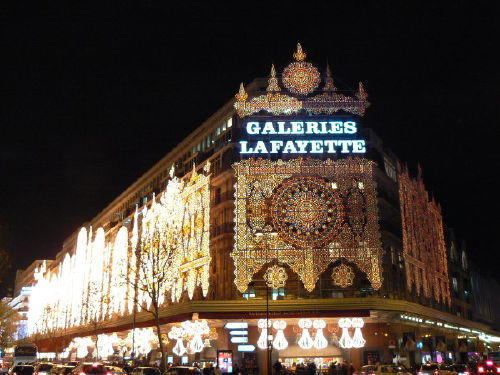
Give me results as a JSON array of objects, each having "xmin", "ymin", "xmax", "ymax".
[{"xmin": 28, "ymin": 168, "xmax": 211, "ymax": 334}]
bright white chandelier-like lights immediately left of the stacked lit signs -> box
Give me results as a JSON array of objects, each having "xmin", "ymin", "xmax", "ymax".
[{"xmin": 168, "ymin": 317, "xmax": 212, "ymax": 356}]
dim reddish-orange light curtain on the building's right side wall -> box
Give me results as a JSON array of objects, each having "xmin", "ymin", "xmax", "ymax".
[{"xmin": 398, "ymin": 166, "xmax": 451, "ymax": 305}]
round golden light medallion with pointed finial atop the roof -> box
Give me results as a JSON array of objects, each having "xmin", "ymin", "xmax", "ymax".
[{"xmin": 283, "ymin": 43, "xmax": 321, "ymax": 95}]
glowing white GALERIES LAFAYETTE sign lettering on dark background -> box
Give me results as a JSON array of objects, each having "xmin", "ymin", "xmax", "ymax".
[{"xmin": 240, "ymin": 121, "xmax": 366, "ymax": 154}]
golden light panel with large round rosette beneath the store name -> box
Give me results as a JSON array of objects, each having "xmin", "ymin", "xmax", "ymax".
[{"xmin": 231, "ymin": 158, "xmax": 382, "ymax": 293}]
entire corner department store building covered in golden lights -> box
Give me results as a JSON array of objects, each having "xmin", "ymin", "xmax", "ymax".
[{"xmin": 16, "ymin": 45, "xmax": 496, "ymax": 370}]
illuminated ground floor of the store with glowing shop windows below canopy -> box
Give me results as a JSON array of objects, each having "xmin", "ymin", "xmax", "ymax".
[{"xmin": 33, "ymin": 297, "xmax": 498, "ymax": 373}]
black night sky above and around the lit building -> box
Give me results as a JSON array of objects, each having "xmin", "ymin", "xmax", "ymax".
[{"xmin": 0, "ymin": 1, "xmax": 500, "ymax": 288}]
